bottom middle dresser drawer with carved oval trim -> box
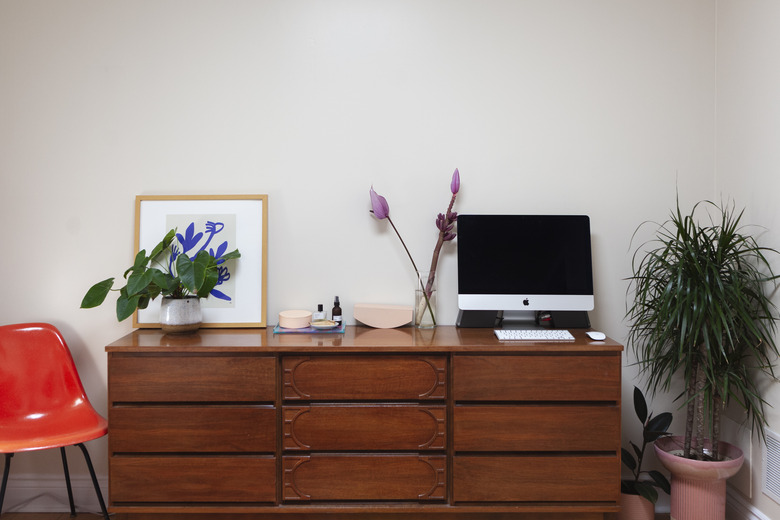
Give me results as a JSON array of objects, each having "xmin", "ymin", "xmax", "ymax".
[{"xmin": 283, "ymin": 454, "xmax": 447, "ymax": 502}]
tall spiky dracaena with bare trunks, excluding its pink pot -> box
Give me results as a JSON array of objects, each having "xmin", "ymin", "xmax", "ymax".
[{"xmin": 627, "ymin": 201, "xmax": 778, "ymax": 460}]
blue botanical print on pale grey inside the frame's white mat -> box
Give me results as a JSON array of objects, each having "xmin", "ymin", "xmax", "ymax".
[{"xmin": 167, "ymin": 215, "xmax": 237, "ymax": 307}]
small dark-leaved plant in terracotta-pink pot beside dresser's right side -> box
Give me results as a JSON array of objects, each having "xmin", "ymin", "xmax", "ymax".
[{"xmin": 618, "ymin": 387, "xmax": 672, "ymax": 520}]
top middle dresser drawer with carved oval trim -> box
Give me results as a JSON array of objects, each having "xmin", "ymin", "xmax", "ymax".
[{"xmin": 282, "ymin": 356, "xmax": 447, "ymax": 401}]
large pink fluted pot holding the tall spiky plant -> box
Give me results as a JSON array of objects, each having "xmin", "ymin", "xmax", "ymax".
[{"xmin": 654, "ymin": 437, "xmax": 745, "ymax": 520}]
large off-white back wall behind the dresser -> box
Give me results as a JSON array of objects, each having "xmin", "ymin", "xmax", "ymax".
[{"xmin": 0, "ymin": 0, "xmax": 720, "ymax": 510}]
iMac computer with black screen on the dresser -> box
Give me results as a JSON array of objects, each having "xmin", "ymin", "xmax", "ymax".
[{"xmin": 457, "ymin": 215, "xmax": 594, "ymax": 328}]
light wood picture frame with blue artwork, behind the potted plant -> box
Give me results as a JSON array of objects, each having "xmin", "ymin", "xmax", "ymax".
[{"xmin": 133, "ymin": 195, "xmax": 268, "ymax": 328}]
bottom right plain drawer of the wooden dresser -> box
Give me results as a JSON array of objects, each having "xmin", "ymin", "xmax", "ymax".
[{"xmin": 452, "ymin": 455, "xmax": 620, "ymax": 503}]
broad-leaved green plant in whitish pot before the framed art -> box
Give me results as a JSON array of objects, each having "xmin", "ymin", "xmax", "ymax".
[{"xmin": 81, "ymin": 229, "xmax": 241, "ymax": 332}]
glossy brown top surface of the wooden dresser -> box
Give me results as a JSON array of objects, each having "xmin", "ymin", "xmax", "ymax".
[{"xmin": 106, "ymin": 326, "xmax": 623, "ymax": 353}]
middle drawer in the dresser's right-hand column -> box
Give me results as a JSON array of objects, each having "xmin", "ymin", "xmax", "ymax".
[{"xmin": 453, "ymin": 405, "xmax": 620, "ymax": 451}]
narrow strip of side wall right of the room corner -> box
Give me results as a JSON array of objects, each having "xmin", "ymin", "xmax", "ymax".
[{"xmin": 717, "ymin": 0, "xmax": 780, "ymax": 518}]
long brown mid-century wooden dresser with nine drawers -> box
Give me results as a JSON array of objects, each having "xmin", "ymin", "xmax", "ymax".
[{"xmin": 106, "ymin": 327, "xmax": 623, "ymax": 520}]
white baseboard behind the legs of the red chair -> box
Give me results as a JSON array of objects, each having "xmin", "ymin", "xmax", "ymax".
[{"xmin": 2, "ymin": 469, "xmax": 108, "ymax": 513}]
